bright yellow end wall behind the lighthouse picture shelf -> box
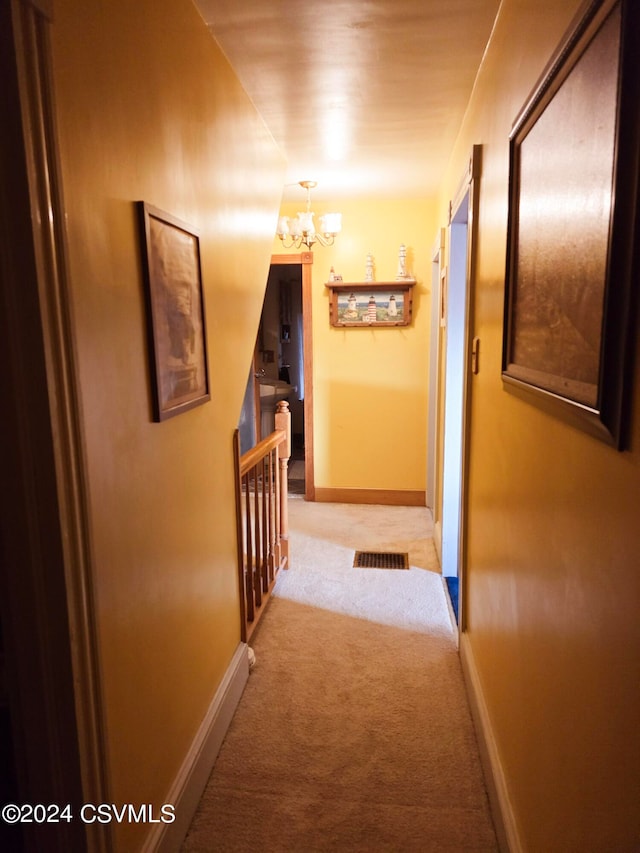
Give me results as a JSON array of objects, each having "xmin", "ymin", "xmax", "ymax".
[{"xmin": 274, "ymin": 198, "xmax": 436, "ymax": 492}]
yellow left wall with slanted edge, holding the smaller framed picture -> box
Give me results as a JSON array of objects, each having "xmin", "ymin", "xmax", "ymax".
[{"xmin": 47, "ymin": 0, "xmax": 283, "ymax": 850}]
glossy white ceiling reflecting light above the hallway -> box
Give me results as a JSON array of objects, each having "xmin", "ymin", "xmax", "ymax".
[{"xmin": 195, "ymin": 0, "xmax": 500, "ymax": 200}]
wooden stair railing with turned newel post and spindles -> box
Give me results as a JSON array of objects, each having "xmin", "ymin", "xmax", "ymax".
[{"xmin": 233, "ymin": 400, "xmax": 291, "ymax": 643}]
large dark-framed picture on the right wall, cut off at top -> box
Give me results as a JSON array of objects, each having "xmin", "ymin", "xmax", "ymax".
[{"xmin": 502, "ymin": 0, "xmax": 640, "ymax": 448}]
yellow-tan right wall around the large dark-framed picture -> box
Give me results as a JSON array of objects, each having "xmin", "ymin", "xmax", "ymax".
[{"xmin": 441, "ymin": 0, "xmax": 640, "ymax": 853}]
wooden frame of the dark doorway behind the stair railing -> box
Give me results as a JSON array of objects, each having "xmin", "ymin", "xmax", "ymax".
[{"xmin": 271, "ymin": 252, "xmax": 316, "ymax": 501}]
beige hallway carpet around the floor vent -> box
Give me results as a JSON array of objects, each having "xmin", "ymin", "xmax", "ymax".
[{"xmin": 182, "ymin": 499, "xmax": 497, "ymax": 853}]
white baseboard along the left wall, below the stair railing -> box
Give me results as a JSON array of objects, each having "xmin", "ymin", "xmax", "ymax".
[{"xmin": 142, "ymin": 643, "xmax": 249, "ymax": 853}]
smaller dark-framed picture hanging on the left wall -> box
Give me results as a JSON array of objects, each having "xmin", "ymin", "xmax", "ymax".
[{"xmin": 137, "ymin": 201, "xmax": 211, "ymax": 421}]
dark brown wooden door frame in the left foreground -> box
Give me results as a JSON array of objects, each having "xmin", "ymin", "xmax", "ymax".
[{"xmin": 0, "ymin": 0, "xmax": 112, "ymax": 853}]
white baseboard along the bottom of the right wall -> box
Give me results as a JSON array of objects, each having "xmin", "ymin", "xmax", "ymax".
[{"xmin": 460, "ymin": 633, "xmax": 524, "ymax": 853}]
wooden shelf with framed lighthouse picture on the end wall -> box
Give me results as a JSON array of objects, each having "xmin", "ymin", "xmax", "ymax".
[{"xmin": 326, "ymin": 279, "xmax": 415, "ymax": 329}]
